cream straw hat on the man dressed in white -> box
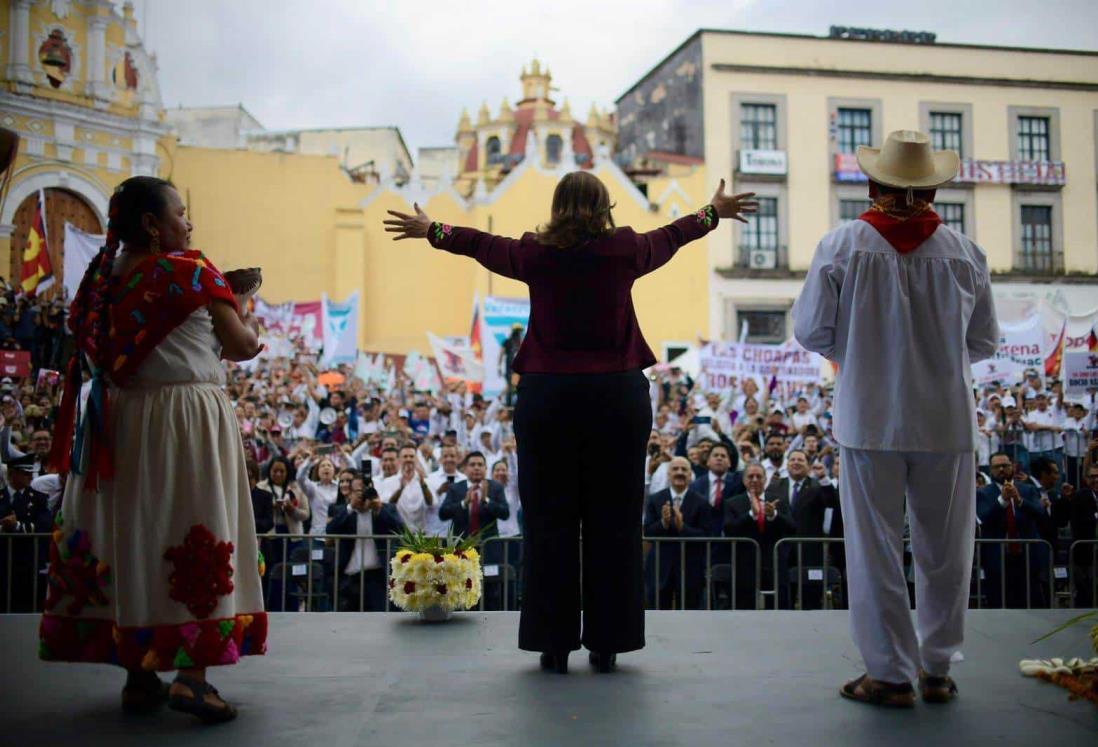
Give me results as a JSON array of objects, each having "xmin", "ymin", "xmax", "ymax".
[{"xmin": 858, "ymin": 130, "xmax": 961, "ymax": 189}]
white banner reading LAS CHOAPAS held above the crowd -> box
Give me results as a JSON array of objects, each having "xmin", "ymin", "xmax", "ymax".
[{"xmin": 701, "ymin": 339, "xmax": 822, "ymax": 391}]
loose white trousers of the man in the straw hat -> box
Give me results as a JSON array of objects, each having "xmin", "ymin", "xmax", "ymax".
[{"xmin": 839, "ymin": 446, "xmax": 976, "ymax": 683}]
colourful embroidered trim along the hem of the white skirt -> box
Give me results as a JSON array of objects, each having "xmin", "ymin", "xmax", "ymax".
[{"xmin": 38, "ymin": 612, "xmax": 267, "ymax": 671}]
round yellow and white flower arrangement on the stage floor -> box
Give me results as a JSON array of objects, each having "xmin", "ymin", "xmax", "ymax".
[{"xmin": 389, "ymin": 522, "xmax": 483, "ymax": 620}]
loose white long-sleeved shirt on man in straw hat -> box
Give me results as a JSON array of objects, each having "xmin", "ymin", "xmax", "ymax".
[{"xmin": 793, "ymin": 221, "xmax": 999, "ymax": 451}]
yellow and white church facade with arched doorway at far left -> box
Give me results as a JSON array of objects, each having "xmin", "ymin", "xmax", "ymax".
[{"xmin": 0, "ymin": 0, "xmax": 168, "ymax": 279}]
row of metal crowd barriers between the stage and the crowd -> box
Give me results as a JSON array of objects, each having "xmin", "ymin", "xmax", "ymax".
[{"xmin": 0, "ymin": 534, "xmax": 1098, "ymax": 613}]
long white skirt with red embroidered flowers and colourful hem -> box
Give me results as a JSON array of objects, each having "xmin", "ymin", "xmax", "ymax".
[{"xmin": 40, "ymin": 383, "xmax": 267, "ymax": 670}]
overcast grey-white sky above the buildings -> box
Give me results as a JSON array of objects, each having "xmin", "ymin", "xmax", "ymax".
[{"xmin": 135, "ymin": 0, "xmax": 1098, "ymax": 157}]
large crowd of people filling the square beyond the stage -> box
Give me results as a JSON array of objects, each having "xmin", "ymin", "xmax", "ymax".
[{"xmin": 0, "ymin": 291, "xmax": 1098, "ymax": 611}]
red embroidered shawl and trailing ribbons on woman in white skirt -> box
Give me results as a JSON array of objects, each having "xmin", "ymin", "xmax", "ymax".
[{"xmin": 49, "ymin": 250, "xmax": 238, "ymax": 490}]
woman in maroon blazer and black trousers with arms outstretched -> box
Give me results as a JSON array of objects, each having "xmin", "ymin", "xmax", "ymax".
[{"xmin": 385, "ymin": 171, "xmax": 757, "ymax": 672}]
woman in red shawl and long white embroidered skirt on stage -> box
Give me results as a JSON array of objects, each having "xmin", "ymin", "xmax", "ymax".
[{"xmin": 40, "ymin": 177, "xmax": 267, "ymax": 722}]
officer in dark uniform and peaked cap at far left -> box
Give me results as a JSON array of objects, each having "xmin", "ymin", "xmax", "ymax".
[{"xmin": 0, "ymin": 454, "xmax": 53, "ymax": 612}]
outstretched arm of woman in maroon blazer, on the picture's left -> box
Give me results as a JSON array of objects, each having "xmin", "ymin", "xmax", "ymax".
[{"xmin": 384, "ymin": 203, "xmax": 525, "ymax": 280}]
